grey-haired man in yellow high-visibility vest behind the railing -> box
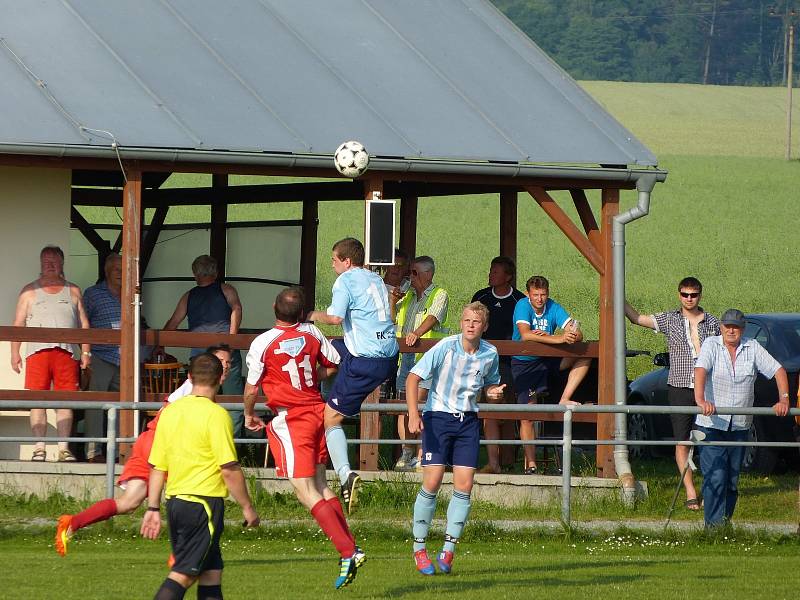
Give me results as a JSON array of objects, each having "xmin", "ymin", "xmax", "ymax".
[{"xmin": 392, "ymin": 256, "xmax": 449, "ymax": 471}]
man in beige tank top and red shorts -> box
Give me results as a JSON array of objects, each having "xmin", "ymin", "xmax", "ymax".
[{"xmin": 11, "ymin": 246, "xmax": 92, "ymax": 462}]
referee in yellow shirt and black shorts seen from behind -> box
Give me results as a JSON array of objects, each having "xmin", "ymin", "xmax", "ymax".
[{"xmin": 141, "ymin": 353, "xmax": 259, "ymax": 600}]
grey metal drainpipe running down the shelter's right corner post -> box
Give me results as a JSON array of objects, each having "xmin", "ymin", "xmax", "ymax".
[{"xmin": 611, "ymin": 175, "xmax": 663, "ymax": 506}]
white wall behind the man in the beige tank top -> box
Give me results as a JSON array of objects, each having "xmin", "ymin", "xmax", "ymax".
[{"xmin": 0, "ymin": 167, "xmax": 71, "ymax": 458}]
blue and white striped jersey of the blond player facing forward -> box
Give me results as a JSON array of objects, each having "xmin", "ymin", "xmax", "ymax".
[{"xmin": 411, "ymin": 334, "xmax": 500, "ymax": 413}]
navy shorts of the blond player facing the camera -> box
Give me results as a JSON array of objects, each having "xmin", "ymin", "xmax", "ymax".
[{"xmin": 422, "ymin": 410, "xmax": 481, "ymax": 469}]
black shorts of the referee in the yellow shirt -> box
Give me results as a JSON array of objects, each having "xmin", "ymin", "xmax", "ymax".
[{"xmin": 167, "ymin": 496, "xmax": 225, "ymax": 577}]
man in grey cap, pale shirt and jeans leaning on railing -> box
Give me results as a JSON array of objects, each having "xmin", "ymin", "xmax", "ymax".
[{"xmin": 694, "ymin": 308, "xmax": 789, "ymax": 527}]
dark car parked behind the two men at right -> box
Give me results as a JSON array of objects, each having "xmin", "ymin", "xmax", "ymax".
[{"xmin": 628, "ymin": 313, "xmax": 800, "ymax": 474}]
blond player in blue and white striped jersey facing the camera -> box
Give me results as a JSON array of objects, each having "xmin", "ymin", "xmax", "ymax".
[{"xmin": 406, "ymin": 302, "xmax": 506, "ymax": 575}]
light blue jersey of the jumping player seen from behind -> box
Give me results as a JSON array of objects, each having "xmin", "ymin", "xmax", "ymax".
[{"xmin": 328, "ymin": 267, "xmax": 400, "ymax": 358}]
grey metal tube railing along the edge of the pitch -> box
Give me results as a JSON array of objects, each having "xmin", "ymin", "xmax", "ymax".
[{"xmin": 0, "ymin": 400, "xmax": 800, "ymax": 527}]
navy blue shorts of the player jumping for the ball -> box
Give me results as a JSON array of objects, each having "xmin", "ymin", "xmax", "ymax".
[{"xmin": 328, "ymin": 340, "xmax": 397, "ymax": 417}]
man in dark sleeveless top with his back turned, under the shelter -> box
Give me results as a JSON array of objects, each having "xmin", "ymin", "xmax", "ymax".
[{"xmin": 164, "ymin": 254, "xmax": 244, "ymax": 438}]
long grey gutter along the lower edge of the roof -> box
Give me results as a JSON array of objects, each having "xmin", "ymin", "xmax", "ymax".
[{"xmin": 0, "ymin": 144, "xmax": 667, "ymax": 183}]
